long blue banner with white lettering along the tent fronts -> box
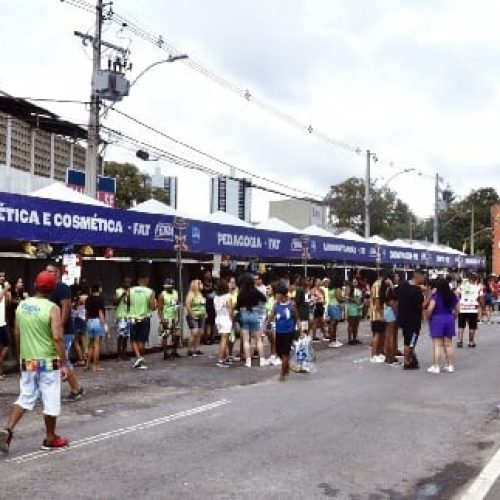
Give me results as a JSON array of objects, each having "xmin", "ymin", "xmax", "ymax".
[{"xmin": 0, "ymin": 193, "xmax": 486, "ymax": 269}]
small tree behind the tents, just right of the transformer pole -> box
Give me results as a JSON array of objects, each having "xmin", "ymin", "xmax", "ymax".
[{"xmin": 104, "ymin": 161, "xmax": 169, "ymax": 208}]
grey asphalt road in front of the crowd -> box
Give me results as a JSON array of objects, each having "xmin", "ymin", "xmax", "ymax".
[{"xmin": 0, "ymin": 318, "xmax": 500, "ymax": 500}]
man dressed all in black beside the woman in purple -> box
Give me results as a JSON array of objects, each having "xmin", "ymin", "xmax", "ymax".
[{"xmin": 394, "ymin": 269, "xmax": 425, "ymax": 370}]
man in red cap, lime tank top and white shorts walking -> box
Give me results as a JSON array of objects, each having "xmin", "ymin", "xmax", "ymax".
[{"xmin": 0, "ymin": 271, "xmax": 69, "ymax": 453}]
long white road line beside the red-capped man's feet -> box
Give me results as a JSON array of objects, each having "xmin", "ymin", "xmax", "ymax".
[{"xmin": 6, "ymin": 399, "xmax": 230, "ymax": 463}]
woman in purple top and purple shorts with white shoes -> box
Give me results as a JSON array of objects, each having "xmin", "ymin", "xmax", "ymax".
[{"xmin": 425, "ymin": 279, "xmax": 460, "ymax": 374}]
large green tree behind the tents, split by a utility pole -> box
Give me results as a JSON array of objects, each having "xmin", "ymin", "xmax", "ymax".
[{"xmin": 326, "ymin": 177, "xmax": 414, "ymax": 239}]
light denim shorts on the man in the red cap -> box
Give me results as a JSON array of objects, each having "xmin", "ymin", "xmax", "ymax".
[{"xmin": 15, "ymin": 370, "xmax": 61, "ymax": 417}]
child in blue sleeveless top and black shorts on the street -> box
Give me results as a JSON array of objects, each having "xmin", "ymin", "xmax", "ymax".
[{"xmin": 270, "ymin": 284, "xmax": 300, "ymax": 382}]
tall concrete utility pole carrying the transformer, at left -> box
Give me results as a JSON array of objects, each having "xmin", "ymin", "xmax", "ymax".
[{"xmin": 85, "ymin": 0, "xmax": 103, "ymax": 198}]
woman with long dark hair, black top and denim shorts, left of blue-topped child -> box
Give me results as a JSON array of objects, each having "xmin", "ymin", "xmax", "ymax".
[{"xmin": 236, "ymin": 273, "xmax": 267, "ymax": 368}]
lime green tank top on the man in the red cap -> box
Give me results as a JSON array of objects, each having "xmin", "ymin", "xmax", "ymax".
[{"xmin": 16, "ymin": 297, "xmax": 59, "ymax": 362}]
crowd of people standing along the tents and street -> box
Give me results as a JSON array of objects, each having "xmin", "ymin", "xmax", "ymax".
[{"xmin": 0, "ymin": 264, "xmax": 500, "ymax": 451}]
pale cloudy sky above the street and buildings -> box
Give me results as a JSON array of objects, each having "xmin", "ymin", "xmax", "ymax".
[{"xmin": 0, "ymin": 0, "xmax": 500, "ymax": 227}]
